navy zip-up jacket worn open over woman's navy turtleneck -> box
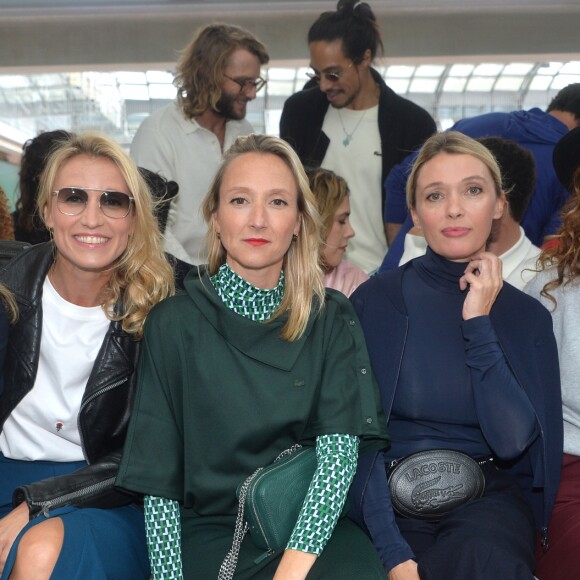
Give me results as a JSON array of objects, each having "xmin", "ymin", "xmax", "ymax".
[{"xmin": 349, "ymin": 262, "xmax": 563, "ymax": 569}]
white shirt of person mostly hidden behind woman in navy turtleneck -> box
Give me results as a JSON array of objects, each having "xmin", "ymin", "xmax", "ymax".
[{"xmin": 399, "ymin": 226, "xmax": 541, "ymax": 290}]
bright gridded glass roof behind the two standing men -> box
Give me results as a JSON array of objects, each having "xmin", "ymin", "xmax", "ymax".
[{"xmin": 0, "ymin": 61, "xmax": 580, "ymax": 150}]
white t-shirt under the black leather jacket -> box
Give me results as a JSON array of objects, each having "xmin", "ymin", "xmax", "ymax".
[{"xmin": 0, "ymin": 276, "xmax": 110, "ymax": 461}]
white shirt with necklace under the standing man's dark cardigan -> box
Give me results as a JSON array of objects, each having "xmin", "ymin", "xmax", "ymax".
[{"xmin": 321, "ymin": 105, "xmax": 387, "ymax": 274}]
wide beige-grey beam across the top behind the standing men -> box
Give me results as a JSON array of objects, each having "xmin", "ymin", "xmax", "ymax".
[{"xmin": 0, "ymin": 0, "xmax": 580, "ymax": 72}]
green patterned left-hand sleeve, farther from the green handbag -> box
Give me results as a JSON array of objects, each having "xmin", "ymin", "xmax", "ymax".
[{"xmin": 144, "ymin": 495, "xmax": 183, "ymax": 580}]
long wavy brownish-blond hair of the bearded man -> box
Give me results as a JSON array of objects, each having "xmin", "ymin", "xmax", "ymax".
[{"xmin": 173, "ymin": 23, "xmax": 270, "ymax": 119}]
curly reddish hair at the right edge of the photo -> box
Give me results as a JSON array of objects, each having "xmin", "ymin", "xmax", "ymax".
[{"xmin": 538, "ymin": 167, "xmax": 580, "ymax": 307}]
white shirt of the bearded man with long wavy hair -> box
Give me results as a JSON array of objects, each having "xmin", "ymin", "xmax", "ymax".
[{"xmin": 131, "ymin": 103, "xmax": 253, "ymax": 264}]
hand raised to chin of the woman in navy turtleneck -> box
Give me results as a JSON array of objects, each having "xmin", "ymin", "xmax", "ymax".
[{"xmin": 459, "ymin": 252, "xmax": 503, "ymax": 320}]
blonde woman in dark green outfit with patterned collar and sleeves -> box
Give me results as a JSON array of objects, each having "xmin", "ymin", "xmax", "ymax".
[{"xmin": 117, "ymin": 135, "xmax": 387, "ymax": 580}]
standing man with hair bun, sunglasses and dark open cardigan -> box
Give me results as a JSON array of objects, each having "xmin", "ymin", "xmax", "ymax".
[{"xmin": 280, "ymin": 0, "xmax": 436, "ymax": 273}]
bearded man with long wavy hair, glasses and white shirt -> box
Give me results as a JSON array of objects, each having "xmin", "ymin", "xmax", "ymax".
[{"xmin": 131, "ymin": 24, "xmax": 269, "ymax": 264}]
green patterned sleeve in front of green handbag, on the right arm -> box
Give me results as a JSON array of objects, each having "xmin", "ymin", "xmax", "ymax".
[{"xmin": 286, "ymin": 435, "xmax": 359, "ymax": 556}]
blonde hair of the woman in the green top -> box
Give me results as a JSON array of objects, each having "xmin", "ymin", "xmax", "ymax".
[{"xmin": 202, "ymin": 135, "xmax": 324, "ymax": 341}]
